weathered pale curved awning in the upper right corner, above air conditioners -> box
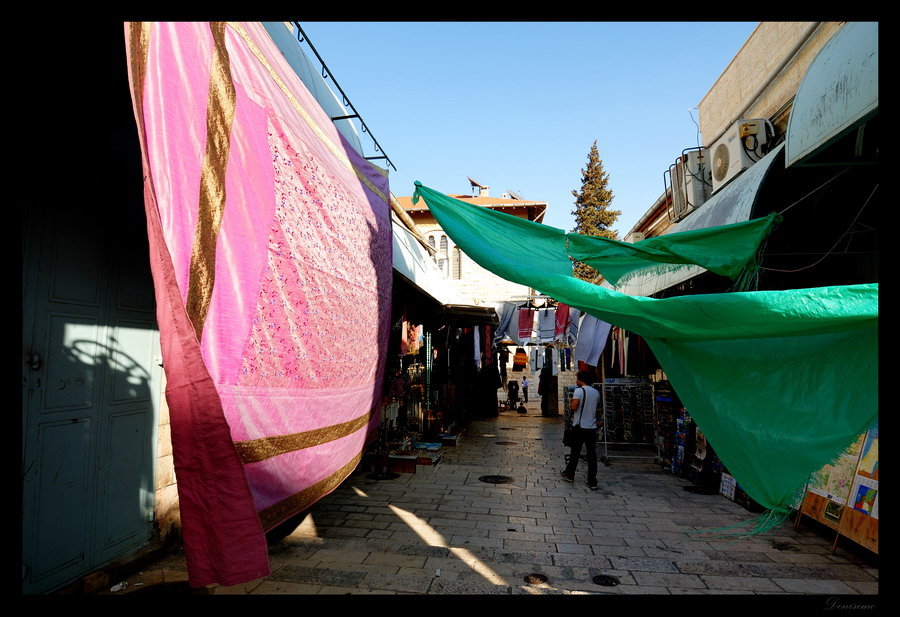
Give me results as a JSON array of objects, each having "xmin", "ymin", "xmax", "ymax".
[{"xmin": 785, "ymin": 22, "xmax": 878, "ymax": 167}]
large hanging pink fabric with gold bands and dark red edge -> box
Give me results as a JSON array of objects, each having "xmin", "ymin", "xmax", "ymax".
[{"xmin": 125, "ymin": 22, "xmax": 391, "ymax": 586}]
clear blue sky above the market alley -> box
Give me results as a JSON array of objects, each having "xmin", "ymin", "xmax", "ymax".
[{"xmin": 300, "ymin": 22, "xmax": 758, "ymax": 237}]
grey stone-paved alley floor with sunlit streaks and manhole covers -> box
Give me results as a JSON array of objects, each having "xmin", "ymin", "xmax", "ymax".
[{"xmin": 95, "ymin": 401, "xmax": 878, "ymax": 596}]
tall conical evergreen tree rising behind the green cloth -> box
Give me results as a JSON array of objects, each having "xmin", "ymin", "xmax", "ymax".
[{"xmin": 572, "ymin": 140, "xmax": 622, "ymax": 282}]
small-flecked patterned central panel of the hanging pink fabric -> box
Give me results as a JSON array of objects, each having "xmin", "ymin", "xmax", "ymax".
[{"xmin": 238, "ymin": 131, "xmax": 391, "ymax": 388}]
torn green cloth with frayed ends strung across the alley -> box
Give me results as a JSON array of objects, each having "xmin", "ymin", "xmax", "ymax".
[{"xmin": 413, "ymin": 182, "xmax": 878, "ymax": 514}]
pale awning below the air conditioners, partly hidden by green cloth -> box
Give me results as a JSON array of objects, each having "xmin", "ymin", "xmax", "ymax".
[{"xmin": 603, "ymin": 144, "xmax": 784, "ymax": 296}]
